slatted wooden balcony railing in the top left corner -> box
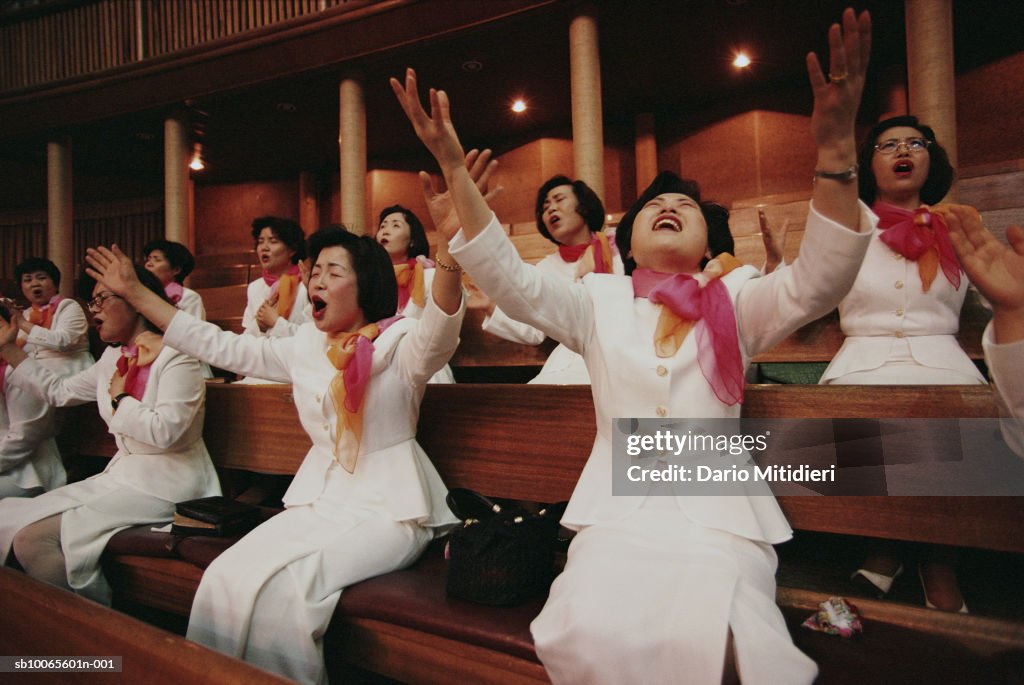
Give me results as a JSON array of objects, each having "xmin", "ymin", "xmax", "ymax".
[{"xmin": 0, "ymin": 0, "xmax": 356, "ymax": 92}]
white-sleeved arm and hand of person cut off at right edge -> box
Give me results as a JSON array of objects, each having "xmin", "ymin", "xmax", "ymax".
[{"xmin": 946, "ymin": 206, "xmax": 1024, "ymax": 457}]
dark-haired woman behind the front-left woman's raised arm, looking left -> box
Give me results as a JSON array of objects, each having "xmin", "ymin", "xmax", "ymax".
[{"xmin": 374, "ymin": 205, "xmax": 455, "ymax": 383}]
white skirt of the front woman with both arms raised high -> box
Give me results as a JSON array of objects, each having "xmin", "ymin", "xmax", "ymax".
[{"xmin": 530, "ymin": 497, "xmax": 817, "ymax": 685}]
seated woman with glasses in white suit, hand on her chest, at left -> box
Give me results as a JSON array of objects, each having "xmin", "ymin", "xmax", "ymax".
[{"xmin": 0, "ymin": 262, "xmax": 220, "ymax": 603}]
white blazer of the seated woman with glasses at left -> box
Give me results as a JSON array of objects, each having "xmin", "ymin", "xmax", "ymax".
[{"xmin": 8, "ymin": 344, "xmax": 220, "ymax": 502}]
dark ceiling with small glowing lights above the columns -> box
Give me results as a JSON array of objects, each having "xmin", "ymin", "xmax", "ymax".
[{"xmin": 0, "ymin": 0, "xmax": 1024, "ymax": 208}]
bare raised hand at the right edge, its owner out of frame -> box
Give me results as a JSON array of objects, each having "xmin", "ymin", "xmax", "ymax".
[{"xmin": 937, "ymin": 205, "xmax": 1024, "ymax": 315}]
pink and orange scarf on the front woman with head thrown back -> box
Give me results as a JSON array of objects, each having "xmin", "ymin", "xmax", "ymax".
[{"xmin": 633, "ymin": 255, "xmax": 743, "ymax": 405}]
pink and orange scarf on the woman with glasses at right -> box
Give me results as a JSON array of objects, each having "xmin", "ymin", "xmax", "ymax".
[{"xmin": 871, "ymin": 201, "xmax": 961, "ymax": 293}]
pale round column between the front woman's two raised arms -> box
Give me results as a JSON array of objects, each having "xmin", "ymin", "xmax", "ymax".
[{"xmin": 569, "ymin": 5, "xmax": 604, "ymax": 200}]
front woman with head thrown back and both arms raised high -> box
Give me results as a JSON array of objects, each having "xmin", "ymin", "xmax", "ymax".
[{"xmin": 392, "ymin": 10, "xmax": 872, "ymax": 685}]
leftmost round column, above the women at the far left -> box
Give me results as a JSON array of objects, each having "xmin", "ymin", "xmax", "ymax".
[{"xmin": 46, "ymin": 136, "xmax": 76, "ymax": 297}]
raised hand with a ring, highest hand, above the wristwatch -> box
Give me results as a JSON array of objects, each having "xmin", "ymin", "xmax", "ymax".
[{"xmin": 807, "ymin": 8, "xmax": 871, "ymax": 147}]
